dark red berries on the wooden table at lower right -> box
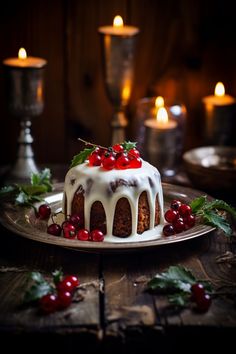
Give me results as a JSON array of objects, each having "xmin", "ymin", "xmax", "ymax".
[{"xmin": 191, "ymin": 283, "xmax": 211, "ymax": 312}]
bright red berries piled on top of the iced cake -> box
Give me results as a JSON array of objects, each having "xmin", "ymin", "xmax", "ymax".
[{"xmin": 88, "ymin": 144, "xmax": 142, "ymax": 171}]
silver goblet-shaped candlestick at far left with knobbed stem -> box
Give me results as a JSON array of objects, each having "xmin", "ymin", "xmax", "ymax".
[{"xmin": 3, "ymin": 49, "xmax": 47, "ymax": 182}]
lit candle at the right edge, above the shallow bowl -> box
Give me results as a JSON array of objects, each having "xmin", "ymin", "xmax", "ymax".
[{"xmin": 202, "ymin": 82, "xmax": 236, "ymax": 145}]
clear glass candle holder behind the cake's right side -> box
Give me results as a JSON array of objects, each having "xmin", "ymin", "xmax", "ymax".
[{"xmin": 135, "ymin": 97, "xmax": 186, "ymax": 177}]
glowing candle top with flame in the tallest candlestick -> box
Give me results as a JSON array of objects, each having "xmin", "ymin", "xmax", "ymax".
[{"xmin": 98, "ymin": 16, "xmax": 139, "ymax": 37}]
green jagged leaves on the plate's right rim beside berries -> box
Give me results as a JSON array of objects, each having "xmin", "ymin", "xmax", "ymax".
[{"xmin": 190, "ymin": 195, "xmax": 236, "ymax": 236}]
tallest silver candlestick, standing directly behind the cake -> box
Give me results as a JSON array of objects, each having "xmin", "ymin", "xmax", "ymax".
[{"xmin": 98, "ymin": 16, "xmax": 139, "ymax": 145}]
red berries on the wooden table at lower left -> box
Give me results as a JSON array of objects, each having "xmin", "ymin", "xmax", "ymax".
[{"xmin": 39, "ymin": 275, "xmax": 79, "ymax": 314}]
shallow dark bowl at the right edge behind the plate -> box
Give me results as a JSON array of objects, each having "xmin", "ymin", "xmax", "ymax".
[{"xmin": 183, "ymin": 146, "xmax": 236, "ymax": 193}]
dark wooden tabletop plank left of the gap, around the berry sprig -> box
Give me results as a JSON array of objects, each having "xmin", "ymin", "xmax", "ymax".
[{"xmin": 0, "ymin": 229, "xmax": 100, "ymax": 337}]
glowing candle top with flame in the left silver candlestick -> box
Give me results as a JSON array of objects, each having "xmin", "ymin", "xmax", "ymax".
[{"xmin": 3, "ymin": 48, "xmax": 47, "ymax": 69}]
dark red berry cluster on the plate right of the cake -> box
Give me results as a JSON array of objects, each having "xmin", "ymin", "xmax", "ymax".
[{"xmin": 163, "ymin": 200, "xmax": 195, "ymax": 236}]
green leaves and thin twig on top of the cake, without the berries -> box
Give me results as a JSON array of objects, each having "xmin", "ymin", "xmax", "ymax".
[{"xmin": 70, "ymin": 138, "xmax": 137, "ymax": 168}]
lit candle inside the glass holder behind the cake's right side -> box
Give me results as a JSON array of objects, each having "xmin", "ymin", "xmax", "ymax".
[{"xmin": 144, "ymin": 106, "xmax": 178, "ymax": 176}]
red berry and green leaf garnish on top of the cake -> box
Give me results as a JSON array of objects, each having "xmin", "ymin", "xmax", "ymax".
[{"xmin": 70, "ymin": 138, "xmax": 142, "ymax": 171}]
